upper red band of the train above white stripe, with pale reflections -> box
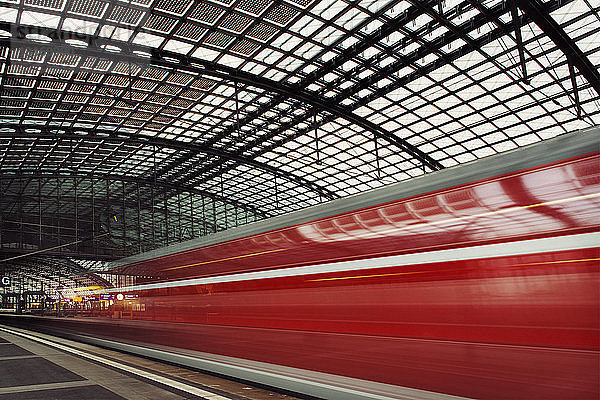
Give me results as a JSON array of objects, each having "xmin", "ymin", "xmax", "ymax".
[{"xmin": 117, "ymin": 153, "xmax": 600, "ymax": 280}]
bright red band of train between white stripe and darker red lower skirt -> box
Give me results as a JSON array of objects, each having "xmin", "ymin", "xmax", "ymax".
[{"xmin": 120, "ymin": 248, "xmax": 600, "ymax": 349}]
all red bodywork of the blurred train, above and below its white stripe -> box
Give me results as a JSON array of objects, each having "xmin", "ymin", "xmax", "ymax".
[{"xmin": 44, "ymin": 148, "xmax": 600, "ymax": 400}]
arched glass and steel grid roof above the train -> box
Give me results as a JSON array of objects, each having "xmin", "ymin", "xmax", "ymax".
[{"xmin": 0, "ymin": 0, "xmax": 600, "ymax": 272}]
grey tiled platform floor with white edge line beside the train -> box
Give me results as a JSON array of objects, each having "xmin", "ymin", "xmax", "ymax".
[{"xmin": 0, "ymin": 325, "xmax": 296, "ymax": 400}]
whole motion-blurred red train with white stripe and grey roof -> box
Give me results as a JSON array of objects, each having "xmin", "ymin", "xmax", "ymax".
[{"xmin": 2, "ymin": 128, "xmax": 600, "ymax": 399}]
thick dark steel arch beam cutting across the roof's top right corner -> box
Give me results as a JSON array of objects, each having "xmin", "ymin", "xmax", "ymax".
[{"xmin": 515, "ymin": 0, "xmax": 600, "ymax": 95}]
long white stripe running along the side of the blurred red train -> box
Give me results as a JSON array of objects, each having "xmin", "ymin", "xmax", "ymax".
[{"xmin": 90, "ymin": 232, "xmax": 600, "ymax": 294}]
